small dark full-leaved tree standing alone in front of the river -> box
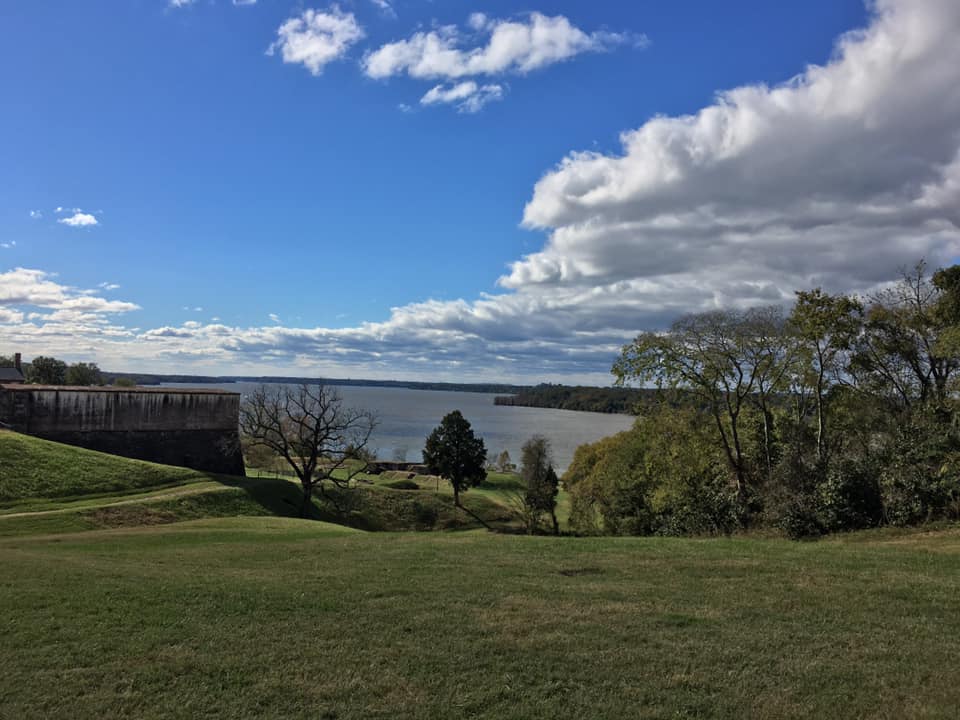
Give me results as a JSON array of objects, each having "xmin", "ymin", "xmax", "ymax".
[{"xmin": 423, "ymin": 410, "xmax": 487, "ymax": 507}]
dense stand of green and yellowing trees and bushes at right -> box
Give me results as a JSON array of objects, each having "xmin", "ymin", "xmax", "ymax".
[{"xmin": 596, "ymin": 263, "xmax": 960, "ymax": 538}]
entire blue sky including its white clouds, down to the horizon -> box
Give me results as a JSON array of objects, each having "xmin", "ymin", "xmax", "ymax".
[{"xmin": 0, "ymin": 0, "xmax": 960, "ymax": 382}]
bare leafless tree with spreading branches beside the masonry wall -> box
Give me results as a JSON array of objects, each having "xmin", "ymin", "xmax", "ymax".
[{"xmin": 240, "ymin": 384, "xmax": 377, "ymax": 517}]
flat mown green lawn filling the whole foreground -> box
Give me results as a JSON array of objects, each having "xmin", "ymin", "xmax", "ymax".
[{"xmin": 0, "ymin": 518, "xmax": 960, "ymax": 720}]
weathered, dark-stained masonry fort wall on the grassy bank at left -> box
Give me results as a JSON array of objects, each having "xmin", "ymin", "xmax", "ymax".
[{"xmin": 0, "ymin": 385, "xmax": 243, "ymax": 475}]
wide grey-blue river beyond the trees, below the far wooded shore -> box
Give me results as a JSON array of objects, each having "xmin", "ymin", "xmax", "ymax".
[{"xmin": 163, "ymin": 383, "xmax": 633, "ymax": 472}]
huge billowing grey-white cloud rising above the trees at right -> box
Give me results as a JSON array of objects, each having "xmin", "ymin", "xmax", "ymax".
[{"xmin": 500, "ymin": 0, "xmax": 960, "ymax": 324}]
